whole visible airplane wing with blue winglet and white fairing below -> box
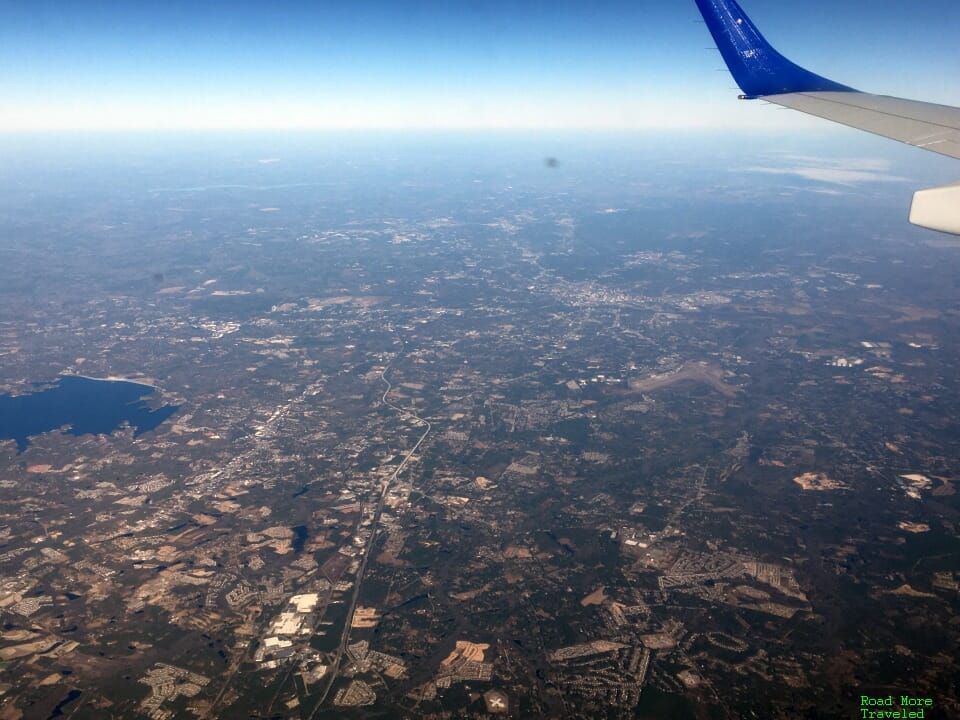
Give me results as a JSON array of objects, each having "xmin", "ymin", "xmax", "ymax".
[{"xmin": 696, "ymin": 0, "xmax": 960, "ymax": 235}]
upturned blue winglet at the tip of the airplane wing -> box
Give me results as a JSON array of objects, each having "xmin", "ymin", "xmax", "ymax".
[{"xmin": 696, "ymin": 0, "xmax": 856, "ymax": 98}]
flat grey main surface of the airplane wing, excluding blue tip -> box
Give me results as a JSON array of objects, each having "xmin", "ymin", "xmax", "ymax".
[{"xmin": 763, "ymin": 92, "xmax": 960, "ymax": 159}]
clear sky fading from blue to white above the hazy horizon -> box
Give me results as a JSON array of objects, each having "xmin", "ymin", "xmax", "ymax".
[{"xmin": 0, "ymin": 0, "xmax": 960, "ymax": 130}]
